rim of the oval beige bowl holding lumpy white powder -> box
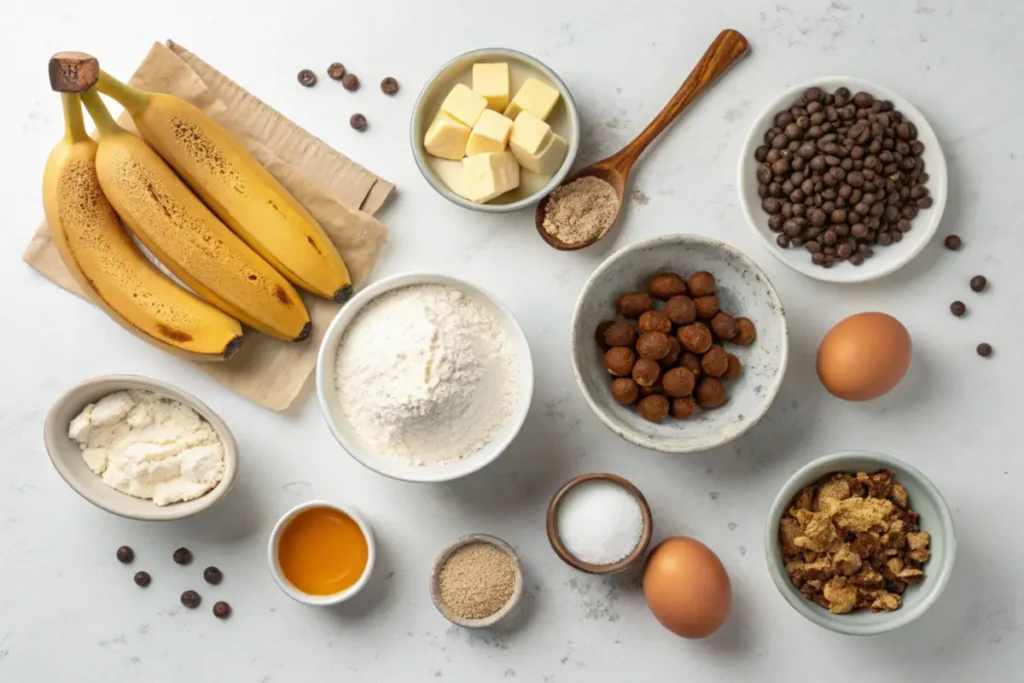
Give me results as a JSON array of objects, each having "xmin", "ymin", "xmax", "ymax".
[{"xmin": 43, "ymin": 375, "xmax": 241, "ymax": 522}]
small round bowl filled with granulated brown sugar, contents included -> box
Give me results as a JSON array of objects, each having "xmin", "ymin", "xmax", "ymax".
[{"xmin": 430, "ymin": 533, "xmax": 522, "ymax": 629}]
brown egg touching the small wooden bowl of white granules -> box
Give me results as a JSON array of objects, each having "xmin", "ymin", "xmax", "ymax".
[{"xmin": 643, "ymin": 537, "xmax": 732, "ymax": 638}]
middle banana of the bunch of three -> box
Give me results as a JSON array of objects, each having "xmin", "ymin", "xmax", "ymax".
[{"xmin": 82, "ymin": 89, "xmax": 310, "ymax": 341}]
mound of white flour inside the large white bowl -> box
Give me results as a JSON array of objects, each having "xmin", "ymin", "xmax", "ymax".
[{"xmin": 336, "ymin": 285, "xmax": 519, "ymax": 465}]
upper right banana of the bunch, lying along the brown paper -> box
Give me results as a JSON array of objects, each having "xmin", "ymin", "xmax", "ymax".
[{"xmin": 96, "ymin": 72, "xmax": 352, "ymax": 303}]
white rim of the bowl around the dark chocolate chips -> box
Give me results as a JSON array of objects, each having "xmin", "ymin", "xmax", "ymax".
[{"xmin": 736, "ymin": 75, "xmax": 949, "ymax": 285}]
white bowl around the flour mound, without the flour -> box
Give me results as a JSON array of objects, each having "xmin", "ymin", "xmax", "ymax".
[{"xmin": 316, "ymin": 272, "xmax": 534, "ymax": 481}]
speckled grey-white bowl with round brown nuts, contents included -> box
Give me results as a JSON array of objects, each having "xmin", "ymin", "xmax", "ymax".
[{"xmin": 569, "ymin": 234, "xmax": 788, "ymax": 453}]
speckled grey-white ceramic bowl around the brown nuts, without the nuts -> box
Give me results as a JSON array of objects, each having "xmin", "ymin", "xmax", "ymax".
[{"xmin": 569, "ymin": 234, "xmax": 790, "ymax": 453}]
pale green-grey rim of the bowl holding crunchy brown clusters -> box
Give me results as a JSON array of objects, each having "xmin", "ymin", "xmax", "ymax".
[{"xmin": 764, "ymin": 451, "xmax": 956, "ymax": 636}]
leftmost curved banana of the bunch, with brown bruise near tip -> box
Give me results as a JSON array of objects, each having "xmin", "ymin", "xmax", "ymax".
[{"xmin": 43, "ymin": 93, "xmax": 242, "ymax": 360}]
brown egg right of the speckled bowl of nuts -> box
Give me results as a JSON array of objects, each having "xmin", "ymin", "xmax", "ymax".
[{"xmin": 818, "ymin": 313, "xmax": 912, "ymax": 400}]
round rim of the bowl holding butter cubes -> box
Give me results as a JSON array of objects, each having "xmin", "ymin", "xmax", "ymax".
[{"xmin": 409, "ymin": 47, "xmax": 580, "ymax": 213}]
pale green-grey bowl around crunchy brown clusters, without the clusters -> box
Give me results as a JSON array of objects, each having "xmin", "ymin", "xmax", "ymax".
[{"xmin": 765, "ymin": 451, "xmax": 956, "ymax": 636}]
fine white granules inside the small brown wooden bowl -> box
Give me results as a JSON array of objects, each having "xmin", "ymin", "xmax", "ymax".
[{"xmin": 557, "ymin": 479, "xmax": 643, "ymax": 564}]
